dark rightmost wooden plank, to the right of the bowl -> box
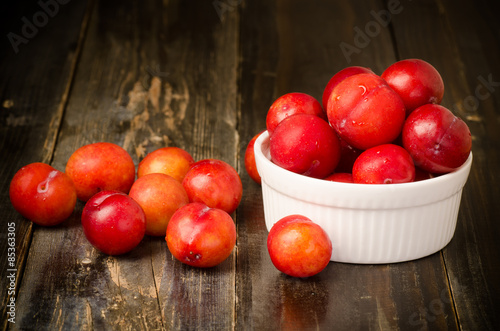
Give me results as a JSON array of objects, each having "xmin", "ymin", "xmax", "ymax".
[{"xmin": 394, "ymin": 0, "xmax": 500, "ymax": 330}]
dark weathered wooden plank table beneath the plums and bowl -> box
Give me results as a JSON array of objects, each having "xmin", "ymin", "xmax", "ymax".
[{"xmin": 0, "ymin": 0, "xmax": 500, "ymax": 330}]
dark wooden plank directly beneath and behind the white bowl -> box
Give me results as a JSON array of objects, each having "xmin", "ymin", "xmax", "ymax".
[{"xmin": 237, "ymin": 1, "xmax": 458, "ymax": 330}]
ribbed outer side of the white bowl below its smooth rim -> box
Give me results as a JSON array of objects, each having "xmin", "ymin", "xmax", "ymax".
[{"xmin": 262, "ymin": 182, "xmax": 462, "ymax": 263}]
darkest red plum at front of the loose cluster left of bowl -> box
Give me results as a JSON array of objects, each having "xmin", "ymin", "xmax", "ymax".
[{"xmin": 82, "ymin": 191, "xmax": 146, "ymax": 255}]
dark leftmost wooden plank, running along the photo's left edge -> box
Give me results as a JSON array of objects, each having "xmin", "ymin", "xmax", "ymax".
[{"xmin": 0, "ymin": 1, "xmax": 87, "ymax": 329}]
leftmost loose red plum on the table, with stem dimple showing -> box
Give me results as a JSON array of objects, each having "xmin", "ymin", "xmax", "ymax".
[{"xmin": 9, "ymin": 162, "xmax": 76, "ymax": 226}]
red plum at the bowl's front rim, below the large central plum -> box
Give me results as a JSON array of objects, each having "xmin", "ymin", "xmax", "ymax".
[{"xmin": 352, "ymin": 144, "xmax": 415, "ymax": 184}]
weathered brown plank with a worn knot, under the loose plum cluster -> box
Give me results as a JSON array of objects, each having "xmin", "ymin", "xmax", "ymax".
[{"xmin": 11, "ymin": 1, "xmax": 238, "ymax": 330}]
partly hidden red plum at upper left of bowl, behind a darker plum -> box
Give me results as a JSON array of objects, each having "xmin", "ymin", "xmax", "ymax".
[{"xmin": 266, "ymin": 92, "xmax": 327, "ymax": 135}]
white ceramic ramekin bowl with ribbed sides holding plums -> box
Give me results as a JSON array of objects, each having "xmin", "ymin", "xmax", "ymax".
[{"xmin": 254, "ymin": 131, "xmax": 472, "ymax": 263}]
